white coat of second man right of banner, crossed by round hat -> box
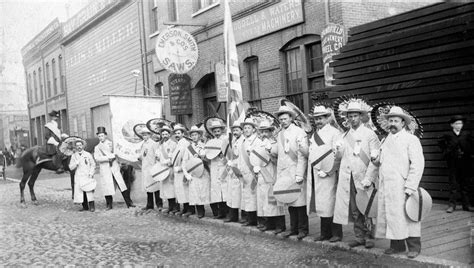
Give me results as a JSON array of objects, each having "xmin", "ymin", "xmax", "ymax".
[{"xmin": 155, "ymin": 139, "xmax": 176, "ymax": 199}]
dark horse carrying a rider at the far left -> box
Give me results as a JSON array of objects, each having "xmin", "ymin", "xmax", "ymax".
[{"xmin": 17, "ymin": 146, "xmax": 74, "ymax": 207}]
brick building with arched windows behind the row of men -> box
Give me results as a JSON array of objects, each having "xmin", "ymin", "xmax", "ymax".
[{"xmin": 144, "ymin": 0, "xmax": 436, "ymax": 125}]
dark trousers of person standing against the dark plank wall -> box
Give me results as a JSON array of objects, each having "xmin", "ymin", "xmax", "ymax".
[{"xmin": 448, "ymin": 158, "xmax": 470, "ymax": 208}]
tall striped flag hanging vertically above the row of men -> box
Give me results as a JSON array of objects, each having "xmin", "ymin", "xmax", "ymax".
[{"xmin": 224, "ymin": 0, "xmax": 249, "ymax": 135}]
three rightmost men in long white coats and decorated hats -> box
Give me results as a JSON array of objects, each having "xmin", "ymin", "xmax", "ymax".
[{"xmin": 307, "ymin": 101, "xmax": 424, "ymax": 258}]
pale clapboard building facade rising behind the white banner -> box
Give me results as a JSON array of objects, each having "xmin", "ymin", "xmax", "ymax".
[{"xmin": 61, "ymin": 0, "xmax": 145, "ymax": 138}]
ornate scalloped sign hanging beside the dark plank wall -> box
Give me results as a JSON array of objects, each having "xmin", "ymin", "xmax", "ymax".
[{"xmin": 321, "ymin": 24, "xmax": 346, "ymax": 86}]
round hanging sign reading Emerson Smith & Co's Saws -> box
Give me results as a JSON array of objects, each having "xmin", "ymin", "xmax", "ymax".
[{"xmin": 155, "ymin": 28, "xmax": 199, "ymax": 74}]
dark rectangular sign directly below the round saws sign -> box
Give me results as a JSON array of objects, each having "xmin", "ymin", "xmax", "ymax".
[{"xmin": 168, "ymin": 74, "xmax": 193, "ymax": 115}]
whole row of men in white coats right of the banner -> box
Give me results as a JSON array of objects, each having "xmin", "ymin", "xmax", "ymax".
[{"xmin": 133, "ymin": 101, "xmax": 424, "ymax": 258}]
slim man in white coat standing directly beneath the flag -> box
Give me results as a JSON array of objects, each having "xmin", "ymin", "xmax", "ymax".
[{"xmin": 224, "ymin": 121, "xmax": 243, "ymax": 222}]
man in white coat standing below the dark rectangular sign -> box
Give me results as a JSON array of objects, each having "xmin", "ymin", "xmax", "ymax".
[{"xmin": 171, "ymin": 124, "xmax": 196, "ymax": 217}]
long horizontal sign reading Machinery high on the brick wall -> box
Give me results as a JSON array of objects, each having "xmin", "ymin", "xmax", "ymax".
[{"xmin": 232, "ymin": 0, "xmax": 304, "ymax": 44}]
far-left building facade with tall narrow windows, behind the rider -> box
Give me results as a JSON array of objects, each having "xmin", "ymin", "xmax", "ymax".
[{"xmin": 21, "ymin": 19, "xmax": 69, "ymax": 145}]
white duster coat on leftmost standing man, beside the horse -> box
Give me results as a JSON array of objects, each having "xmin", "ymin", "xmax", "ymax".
[{"xmin": 69, "ymin": 151, "xmax": 95, "ymax": 203}]
